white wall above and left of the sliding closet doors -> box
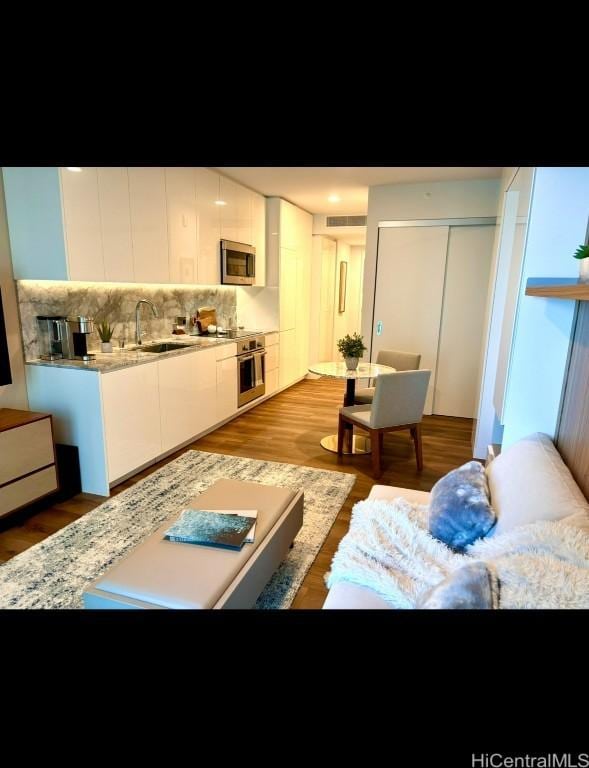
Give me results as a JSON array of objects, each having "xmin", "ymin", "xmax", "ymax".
[{"xmin": 362, "ymin": 179, "xmax": 500, "ymax": 354}]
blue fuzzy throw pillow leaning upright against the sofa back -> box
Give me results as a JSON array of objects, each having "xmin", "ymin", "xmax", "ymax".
[{"xmin": 429, "ymin": 461, "xmax": 497, "ymax": 552}]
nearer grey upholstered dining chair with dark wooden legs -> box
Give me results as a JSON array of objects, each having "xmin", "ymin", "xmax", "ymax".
[{"xmin": 337, "ymin": 370, "xmax": 431, "ymax": 478}]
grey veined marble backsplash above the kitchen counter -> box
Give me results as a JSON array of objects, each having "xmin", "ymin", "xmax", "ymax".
[{"xmin": 16, "ymin": 280, "xmax": 237, "ymax": 360}]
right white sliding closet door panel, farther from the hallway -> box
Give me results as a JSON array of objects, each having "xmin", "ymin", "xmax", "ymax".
[{"xmin": 433, "ymin": 226, "xmax": 495, "ymax": 419}]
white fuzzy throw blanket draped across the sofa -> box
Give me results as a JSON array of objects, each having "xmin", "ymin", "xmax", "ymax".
[{"xmin": 325, "ymin": 498, "xmax": 589, "ymax": 608}]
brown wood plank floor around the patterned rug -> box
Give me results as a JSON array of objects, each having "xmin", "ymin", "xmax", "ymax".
[{"xmin": 0, "ymin": 379, "xmax": 472, "ymax": 608}]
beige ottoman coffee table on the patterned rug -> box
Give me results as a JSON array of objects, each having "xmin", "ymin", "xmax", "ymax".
[{"xmin": 84, "ymin": 480, "xmax": 304, "ymax": 609}]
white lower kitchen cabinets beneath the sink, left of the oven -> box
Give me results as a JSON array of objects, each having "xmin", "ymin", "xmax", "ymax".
[{"xmin": 26, "ymin": 343, "xmax": 247, "ymax": 496}]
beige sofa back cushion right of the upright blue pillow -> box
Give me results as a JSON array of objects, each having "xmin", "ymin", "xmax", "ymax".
[{"xmin": 486, "ymin": 432, "xmax": 589, "ymax": 536}]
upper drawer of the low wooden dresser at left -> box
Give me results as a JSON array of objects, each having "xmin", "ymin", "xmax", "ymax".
[{"xmin": 0, "ymin": 419, "xmax": 55, "ymax": 485}]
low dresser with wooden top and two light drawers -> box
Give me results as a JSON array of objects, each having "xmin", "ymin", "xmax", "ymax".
[{"xmin": 0, "ymin": 408, "xmax": 58, "ymax": 516}]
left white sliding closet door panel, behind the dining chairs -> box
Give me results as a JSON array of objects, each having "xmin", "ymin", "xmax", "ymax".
[{"xmin": 371, "ymin": 227, "xmax": 449, "ymax": 414}]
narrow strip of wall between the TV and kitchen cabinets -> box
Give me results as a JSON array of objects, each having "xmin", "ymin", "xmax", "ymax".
[{"xmin": 0, "ymin": 174, "xmax": 29, "ymax": 410}]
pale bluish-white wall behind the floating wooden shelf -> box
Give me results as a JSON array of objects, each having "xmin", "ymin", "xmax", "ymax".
[{"xmin": 503, "ymin": 168, "xmax": 589, "ymax": 447}]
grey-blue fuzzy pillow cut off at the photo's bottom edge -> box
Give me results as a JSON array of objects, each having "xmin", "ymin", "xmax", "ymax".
[{"xmin": 415, "ymin": 562, "xmax": 498, "ymax": 609}]
